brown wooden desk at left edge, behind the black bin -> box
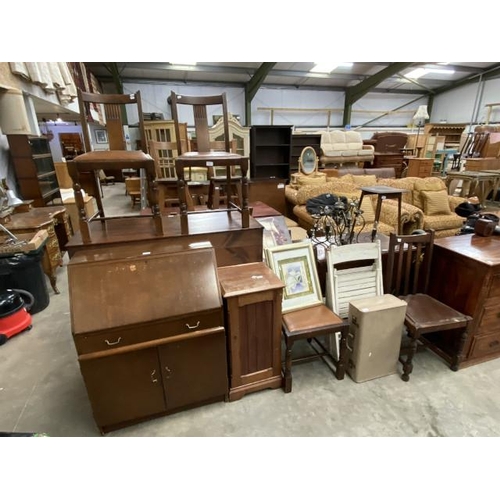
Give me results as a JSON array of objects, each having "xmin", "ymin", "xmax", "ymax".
[{"xmin": 4, "ymin": 205, "xmax": 73, "ymax": 293}]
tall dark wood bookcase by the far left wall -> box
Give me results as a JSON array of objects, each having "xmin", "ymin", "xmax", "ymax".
[{"xmin": 7, "ymin": 135, "xmax": 60, "ymax": 207}]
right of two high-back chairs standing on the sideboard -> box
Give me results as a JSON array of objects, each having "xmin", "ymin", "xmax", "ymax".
[{"xmin": 170, "ymin": 92, "xmax": 250, "ymax": 234}]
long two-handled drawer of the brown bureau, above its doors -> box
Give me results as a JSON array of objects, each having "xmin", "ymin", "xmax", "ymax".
[{"xmin": 73, "ymin": 309, "xmax": 224, "ymax": 354}]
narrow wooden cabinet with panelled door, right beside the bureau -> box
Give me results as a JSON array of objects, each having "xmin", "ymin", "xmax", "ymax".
[{"xmin": 218, "ymin": 262, "xmax": 284, "ymax": 401}]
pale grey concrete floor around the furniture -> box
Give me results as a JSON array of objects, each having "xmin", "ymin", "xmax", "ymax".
[{"xmin": 0, "ymin": 184, "xmax": 500, "ymax": 437}]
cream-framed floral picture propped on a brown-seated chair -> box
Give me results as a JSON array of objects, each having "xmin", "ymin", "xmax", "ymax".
[{"xmin": 266, "ymin": 241, "xmax": 323, "ymax": 312}]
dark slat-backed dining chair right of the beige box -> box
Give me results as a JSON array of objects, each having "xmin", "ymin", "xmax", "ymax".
[{"xmin": 384, "ymin": 230, "xmax": 472, "ymax": 382}]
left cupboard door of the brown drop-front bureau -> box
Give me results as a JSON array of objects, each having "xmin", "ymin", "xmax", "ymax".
[{"xmin": 80, "ymin": 349, "xmax": 165, "ymax": 427}]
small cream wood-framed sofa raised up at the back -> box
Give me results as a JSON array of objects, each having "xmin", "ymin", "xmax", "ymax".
[{"xmin": 319, "ymin": 130, "xmax": 374, "ymax": 166}]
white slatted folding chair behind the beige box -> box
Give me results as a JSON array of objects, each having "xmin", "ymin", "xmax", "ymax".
[{"xmin": 325, "ymin": 240, "xmax": 384, "ymax": 358}]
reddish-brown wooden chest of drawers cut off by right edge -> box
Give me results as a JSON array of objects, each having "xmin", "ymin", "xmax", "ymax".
[{"xmin": 426, "ymin": 234, "xmax": 500, "ymax": 367}]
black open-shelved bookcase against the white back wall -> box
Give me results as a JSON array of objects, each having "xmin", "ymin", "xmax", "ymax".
[{"xmin": 250, "ymin": 125, "xmax": 292, "ymax": 180}]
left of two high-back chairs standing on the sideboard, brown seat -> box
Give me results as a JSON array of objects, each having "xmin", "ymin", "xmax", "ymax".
[{"xmin": 68, "ymin": 89, "xmax": 163, "ymax": 243}]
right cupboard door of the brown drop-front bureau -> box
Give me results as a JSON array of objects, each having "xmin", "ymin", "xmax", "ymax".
[{"xmin": 159, "ymin": 330, "xmax": 228, "ymax": 410}]
